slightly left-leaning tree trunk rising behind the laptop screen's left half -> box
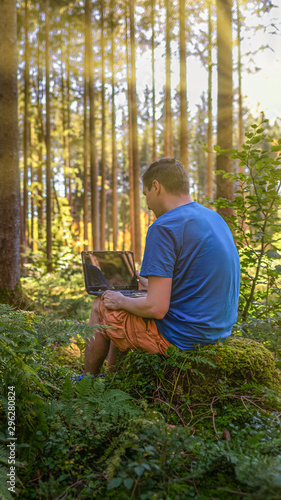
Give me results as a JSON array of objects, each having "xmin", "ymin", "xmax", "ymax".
[{"xmin": 85, "ymin": 0, "xmax": 100, "ymax": 250}]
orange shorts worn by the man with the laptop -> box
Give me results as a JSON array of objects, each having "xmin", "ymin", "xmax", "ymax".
[{"xmin": 100, "ymin": 300, "xmax": 172, "ymax": 354}]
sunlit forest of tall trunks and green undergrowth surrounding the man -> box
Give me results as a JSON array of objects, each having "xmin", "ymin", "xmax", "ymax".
[{"xmin": 0, "ymin": 0, "xmax": 281, "ymax": 500}]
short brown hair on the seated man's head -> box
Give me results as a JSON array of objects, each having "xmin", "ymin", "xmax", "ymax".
[{"xmin": 142, "ymin": 158, "xmax": 189, "ymax": 194}]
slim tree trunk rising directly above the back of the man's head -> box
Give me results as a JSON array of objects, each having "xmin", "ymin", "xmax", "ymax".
[{"xmin": 179, "ymin": 0, "xmax": 188, "ymax": 171}]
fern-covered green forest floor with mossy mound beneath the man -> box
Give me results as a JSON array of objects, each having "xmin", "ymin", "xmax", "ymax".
[{"xmin": 0, "ymin": 269, "xmax": 281, "ymax": 500}]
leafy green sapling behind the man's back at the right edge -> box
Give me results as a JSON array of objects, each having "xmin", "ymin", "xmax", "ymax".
[{"xmin": 207, "ymin": 125, "xmax": 281, "ymax": 321}]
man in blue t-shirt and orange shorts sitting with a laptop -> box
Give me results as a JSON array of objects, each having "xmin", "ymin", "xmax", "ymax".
[{"xmin": 85, "ymin": 158, "xmax": 240, "ymax": 375}]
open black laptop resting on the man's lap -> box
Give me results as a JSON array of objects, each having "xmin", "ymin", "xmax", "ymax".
[{"xmin": 81, "ymin": 250, "xmax": 147, "ymax": 297}]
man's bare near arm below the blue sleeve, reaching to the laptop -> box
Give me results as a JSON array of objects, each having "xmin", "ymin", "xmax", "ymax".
[{"xmin": 102, "ymin": 276, "xmax": 172, "ymax": 319}]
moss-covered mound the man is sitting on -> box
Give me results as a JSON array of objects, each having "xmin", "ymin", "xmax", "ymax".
[{"xmin": 114, "ymin": 335, "xmax": 281, "ymax": 402}]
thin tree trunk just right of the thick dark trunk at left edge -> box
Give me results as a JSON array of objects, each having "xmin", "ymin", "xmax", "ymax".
[{"xmin": 22, "ymin": 0, "xmax": 30, "ymax": 262}]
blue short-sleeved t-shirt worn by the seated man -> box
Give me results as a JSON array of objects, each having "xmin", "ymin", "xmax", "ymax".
[{"xmin": 140, "ymin": 202, "xmax": 240, "ymax": 350}]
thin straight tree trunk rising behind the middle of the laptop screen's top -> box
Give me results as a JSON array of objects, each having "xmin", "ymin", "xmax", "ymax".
[{"xmin": 111, "ymin": 0, "xmax": 118, "ymax": 250}]
